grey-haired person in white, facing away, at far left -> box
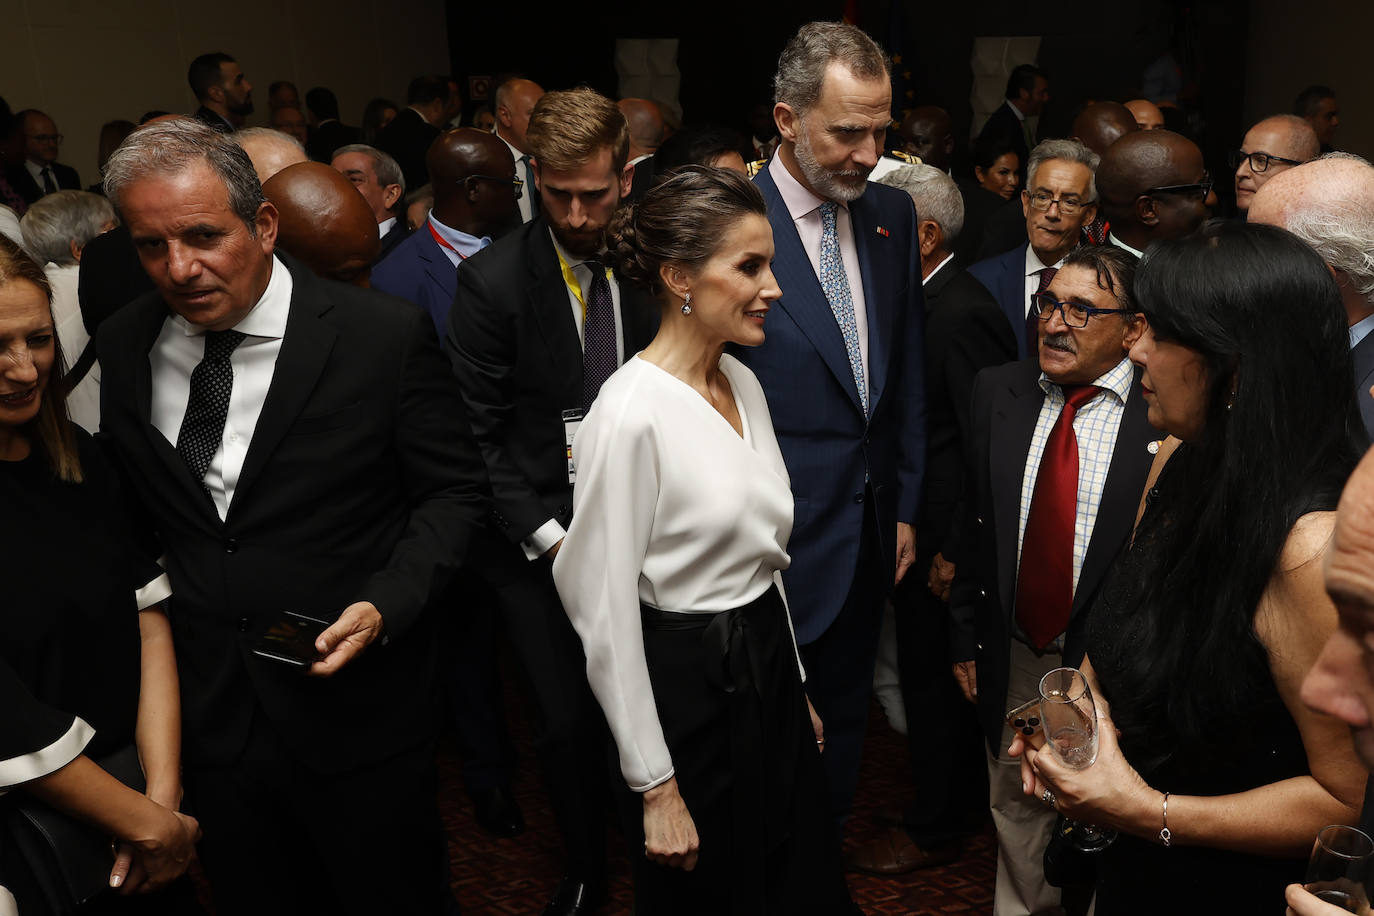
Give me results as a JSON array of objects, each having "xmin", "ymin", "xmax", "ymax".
[{"xmin": 19, "ymin": 191, "xmax": 115, "ymax": 433}]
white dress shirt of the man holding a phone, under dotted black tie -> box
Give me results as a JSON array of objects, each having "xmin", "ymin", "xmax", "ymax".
[{"xmin": 148, "ymin": 255, "xmax": 291, "ymax": 522}]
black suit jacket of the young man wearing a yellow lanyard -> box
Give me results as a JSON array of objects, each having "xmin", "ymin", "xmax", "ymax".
[{"xmin": 444, "ymin": 217, "xmax": 658, "ymax": 563}]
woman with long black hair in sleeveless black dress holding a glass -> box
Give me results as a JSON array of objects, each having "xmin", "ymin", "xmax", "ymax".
[{"xmin": 1013, "ymin": 222, "xmax": 1369, "ymax": 916}]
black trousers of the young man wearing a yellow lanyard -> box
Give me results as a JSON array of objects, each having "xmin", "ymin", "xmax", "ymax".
[{"xmin": 492, "ymin": 560, "xmax": 610, "ymax": 884}]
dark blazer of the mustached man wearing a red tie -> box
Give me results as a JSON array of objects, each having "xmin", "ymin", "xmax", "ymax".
[{"xmin": 949, "ymin": 358, "xmax": 1161, "ymax": 754}]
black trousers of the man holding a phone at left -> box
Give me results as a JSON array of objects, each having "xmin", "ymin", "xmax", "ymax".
[{"xmin": 184, "ymin": 711, "xmax": 456, "ymax": 916}]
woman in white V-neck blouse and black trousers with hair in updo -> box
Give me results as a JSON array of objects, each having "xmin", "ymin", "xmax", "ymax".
[{"xmin": 554, "ymin": 166, "xmax": 853, "ymax": 916}]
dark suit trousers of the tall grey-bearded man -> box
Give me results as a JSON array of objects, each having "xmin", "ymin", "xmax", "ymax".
[{"xmin": 801, "ymin": 490, "xmax": 896, "ymax": 824}]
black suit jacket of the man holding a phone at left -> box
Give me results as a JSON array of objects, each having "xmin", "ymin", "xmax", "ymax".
[{"xmin": 98, "ymin": 254, "xmax": 486, "ymax": 772}]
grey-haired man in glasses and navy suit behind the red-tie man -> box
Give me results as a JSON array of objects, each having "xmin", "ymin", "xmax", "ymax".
[{"xmin": 969, "ymin": 140, "xmax": 1098, "ymax": 360}]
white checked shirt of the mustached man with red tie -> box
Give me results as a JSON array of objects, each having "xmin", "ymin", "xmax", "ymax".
[{"xmin": 1017, "ymin": 354, "xmax": 1135, "ymax": 591}]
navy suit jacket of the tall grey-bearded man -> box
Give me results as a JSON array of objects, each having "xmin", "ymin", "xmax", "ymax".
[{"xmin": 732, "ymin": 169, "xmax": 926, "ymax": 644}]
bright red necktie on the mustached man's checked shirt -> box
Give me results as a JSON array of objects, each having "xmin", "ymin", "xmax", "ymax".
[{"xmin": 1017, "ymin": 385, "xmax": 1102, "ymax": 648}]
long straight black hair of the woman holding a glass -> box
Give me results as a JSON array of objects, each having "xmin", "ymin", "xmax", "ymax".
[{"xmin": 1103, "ymin": 220, "xmax": 1369, "ymax": 768}]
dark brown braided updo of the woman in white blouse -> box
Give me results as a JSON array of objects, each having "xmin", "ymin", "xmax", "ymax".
[{"xmin": 606, "ymin": 165, "xmax": 768, "ymax": 298}]
